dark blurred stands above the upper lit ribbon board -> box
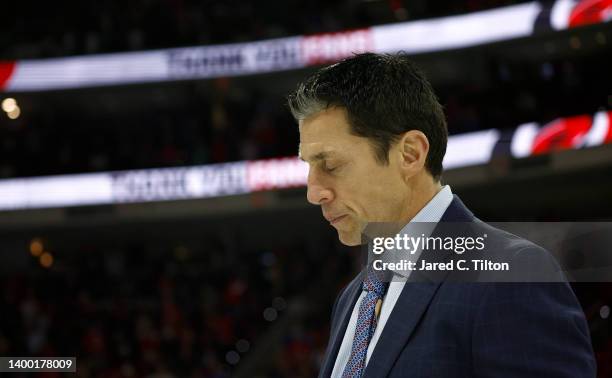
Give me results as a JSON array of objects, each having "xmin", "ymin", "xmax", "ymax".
[{"xmin": 0, "ymin": 0, "xmax": 525, "ymax": 59}]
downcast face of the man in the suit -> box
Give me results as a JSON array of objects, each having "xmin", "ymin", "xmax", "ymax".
[{"xmin": 300, "ymin": 108, "xmax": 410, "ymax": 245}]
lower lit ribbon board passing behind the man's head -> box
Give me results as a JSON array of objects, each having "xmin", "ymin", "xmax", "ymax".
[{"xmin": 0, "ymin": 111, "xmax": 612, "ymax": 211}]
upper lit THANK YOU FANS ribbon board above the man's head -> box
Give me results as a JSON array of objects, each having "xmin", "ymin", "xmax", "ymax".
[{"xmin": 0, "ymin": 0, "xmax": 612, "ymax": 92}]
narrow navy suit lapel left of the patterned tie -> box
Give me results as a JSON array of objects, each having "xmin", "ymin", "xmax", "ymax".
[{"xmin": 319, "ymin": 272, "xmax": 363, "ymax": 377}]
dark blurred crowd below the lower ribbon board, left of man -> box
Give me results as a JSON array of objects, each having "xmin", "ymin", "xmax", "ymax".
[{"xmin": 0, "ymin": 230, "xmax": 350, "ymax": 378}]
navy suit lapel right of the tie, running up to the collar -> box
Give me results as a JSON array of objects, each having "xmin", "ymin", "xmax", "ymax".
[{"xmin": 364, "ymin": 196, "xmax": 474, "ymax": 378}]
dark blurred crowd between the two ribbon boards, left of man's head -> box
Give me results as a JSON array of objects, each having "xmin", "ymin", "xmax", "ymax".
[{"xmin": 0, "ymin": 85, "xmax": 298, "ymax": 177}]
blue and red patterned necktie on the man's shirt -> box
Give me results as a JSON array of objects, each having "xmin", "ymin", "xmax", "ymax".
[{"xmin": 342, "ymin": 270, "xmax": 387, "ymax": 378}]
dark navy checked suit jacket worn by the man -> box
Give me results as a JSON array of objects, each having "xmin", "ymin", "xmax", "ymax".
[{"xmin": 319, "ymin": 196, "xmax": 596, "ymax": 378}]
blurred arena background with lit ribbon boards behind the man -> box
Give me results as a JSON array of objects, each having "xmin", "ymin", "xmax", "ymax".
[{"xmin": 0, "ymin": 0, "xmax": 612, "ymax": 377}]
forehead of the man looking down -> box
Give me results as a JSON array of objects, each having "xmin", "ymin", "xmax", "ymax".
[{"xmin": 299, "ymin": 108, "xmax": 368, "ymax": 161}]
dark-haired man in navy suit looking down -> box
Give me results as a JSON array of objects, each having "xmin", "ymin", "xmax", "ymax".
[{"xmin": 289, "ymin": 53, "xmax": 595, "ymax": 378}]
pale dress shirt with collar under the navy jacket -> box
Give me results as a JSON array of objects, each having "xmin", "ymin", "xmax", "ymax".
[{"xmin": 331, "ymin": 185, "xmax": 453, "ymax": 378}]
